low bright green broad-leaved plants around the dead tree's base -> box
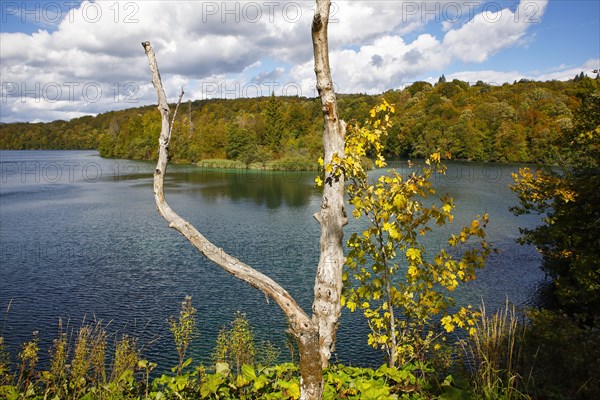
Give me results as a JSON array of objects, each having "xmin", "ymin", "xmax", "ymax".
[{"xmin": 148, "ymin": 363, "xmax": 438, "ymax": 400}]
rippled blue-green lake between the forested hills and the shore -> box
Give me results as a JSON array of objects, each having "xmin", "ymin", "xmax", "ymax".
[{"xmin": 0, "ymin": 151, "xmax": 545, "ymax": 369}]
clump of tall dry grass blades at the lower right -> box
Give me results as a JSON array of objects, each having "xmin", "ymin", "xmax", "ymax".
[{"xmin": 463, "ymin": 301, "xmax": 532, "ymax": 400}]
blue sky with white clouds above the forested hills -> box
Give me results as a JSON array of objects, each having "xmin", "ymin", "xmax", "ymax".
[{"xmin": 0, "ymin": 0, "xmax": 600, "ymax": 122}]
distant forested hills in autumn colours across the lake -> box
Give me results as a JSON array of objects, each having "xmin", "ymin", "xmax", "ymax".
[{"xmin": 0, "ymin": 74, "xmax": 600, "ymax": 164}]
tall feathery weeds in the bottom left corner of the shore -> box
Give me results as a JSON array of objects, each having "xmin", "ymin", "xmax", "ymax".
[{"xmin": 0, "ymin": 320, "xmax": 139, "ymax": 399}]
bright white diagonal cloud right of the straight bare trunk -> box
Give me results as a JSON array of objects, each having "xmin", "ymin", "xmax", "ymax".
[{"xmin": 292, "ymin": 0, "xmax": 547, "ymax": 93}]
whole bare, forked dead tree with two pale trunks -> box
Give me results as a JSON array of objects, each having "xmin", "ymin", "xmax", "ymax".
[{"xmin": 142, "ymin": 0, "xmax": 346, "ymax": 400}]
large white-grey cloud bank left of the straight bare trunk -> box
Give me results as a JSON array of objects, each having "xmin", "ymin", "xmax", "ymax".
[{"xmin": 0, "ymin": 1, "xmax": 311, "ymax": 122}]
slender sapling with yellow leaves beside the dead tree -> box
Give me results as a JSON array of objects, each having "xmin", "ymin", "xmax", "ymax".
[{"xmin": 317, "ymin": 100, "xmax": 490, "ymax": 367}]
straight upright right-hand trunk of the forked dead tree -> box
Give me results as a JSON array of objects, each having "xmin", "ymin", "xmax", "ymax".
[{"xmin": 312, "ymin": 0, "xmax": 348, "ymax": 368}]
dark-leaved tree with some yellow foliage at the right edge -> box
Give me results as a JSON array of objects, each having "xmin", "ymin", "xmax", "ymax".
[{"xmin": 511, "ymin": 90, "xmax": 600, "ymax": 323}]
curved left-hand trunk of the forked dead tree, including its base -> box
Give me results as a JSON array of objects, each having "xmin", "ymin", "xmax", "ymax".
[{"xmin": 142, "ymin": 42, "xmax": 323, "ymax": 400}]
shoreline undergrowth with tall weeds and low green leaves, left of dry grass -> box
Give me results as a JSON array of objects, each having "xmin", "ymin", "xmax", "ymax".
[{"xmin": 0, "ymin": 296, "xmax": 454, "ymax": 400}]
